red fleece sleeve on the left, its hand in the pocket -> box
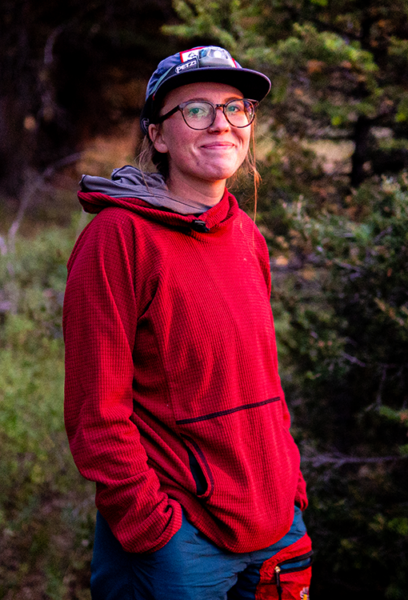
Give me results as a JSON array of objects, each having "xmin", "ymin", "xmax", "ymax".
[{"xmin": 63, "ymin": 210, "xmax": 182, "ymax": 552}]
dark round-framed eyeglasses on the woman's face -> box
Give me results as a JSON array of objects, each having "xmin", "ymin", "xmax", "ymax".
[{"xmin": 156, "ymin": 98, "xmax": 259, "ymax": 129}]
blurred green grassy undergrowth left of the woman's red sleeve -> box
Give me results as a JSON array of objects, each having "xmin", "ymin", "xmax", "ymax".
[{"xmin": 0, "ymin": 230, "xmax": 94, "ymax": 600}]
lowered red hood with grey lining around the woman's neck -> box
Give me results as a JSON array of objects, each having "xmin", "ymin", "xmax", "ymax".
[{"xmin": 78, "ymin": 165, "xmax": 239, "ymax": 233}]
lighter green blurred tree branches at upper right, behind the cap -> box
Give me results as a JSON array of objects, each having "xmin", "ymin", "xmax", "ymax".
[{"xmin": 166, "ymin": 0, "xmax": 408, "ymax": 185}]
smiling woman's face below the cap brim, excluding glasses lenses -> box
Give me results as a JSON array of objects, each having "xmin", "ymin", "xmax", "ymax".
[{"xmin": 149, "ymin": 83, "xmax": 251, "ymax": 193}]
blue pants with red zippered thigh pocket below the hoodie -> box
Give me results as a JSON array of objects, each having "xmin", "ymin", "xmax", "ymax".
[{"xmin": 91, "ymin": 507, "xmax": 312, "ymax": 600}]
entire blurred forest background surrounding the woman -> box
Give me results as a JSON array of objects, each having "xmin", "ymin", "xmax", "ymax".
[{"xmin": 0, "ymin": 0, "xmax": 408, "ymax": 600}]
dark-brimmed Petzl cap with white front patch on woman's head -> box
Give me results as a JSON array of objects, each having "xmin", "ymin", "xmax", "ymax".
[{"xmin": 140, "ymin": 46, "xmax": 271, "ymax": 135}]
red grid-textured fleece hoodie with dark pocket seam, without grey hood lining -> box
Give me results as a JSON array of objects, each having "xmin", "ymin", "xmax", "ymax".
[{"xmin": 64, "ymin": 186, "xmax": 307, "ymax": 552}]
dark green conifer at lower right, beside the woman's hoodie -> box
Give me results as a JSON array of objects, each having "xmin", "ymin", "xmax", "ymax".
[{"xmin": 273, "ymin": 173, "xmax": 408, "ymax": 598}]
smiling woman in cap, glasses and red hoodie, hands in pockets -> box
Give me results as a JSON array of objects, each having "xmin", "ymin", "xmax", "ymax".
[{"xmin": 64, "ymin": 47, "xmax": 311, "ymax": 600}]
